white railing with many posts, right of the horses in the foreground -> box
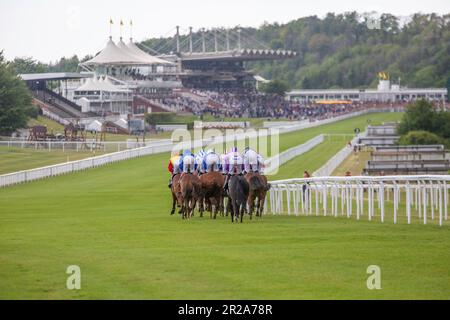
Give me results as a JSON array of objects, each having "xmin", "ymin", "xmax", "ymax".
[{"xmin": 265, "ymin": 175, "xmax": 450, "ymax": 226}]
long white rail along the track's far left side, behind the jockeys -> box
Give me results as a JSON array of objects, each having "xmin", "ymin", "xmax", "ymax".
[{"xmin": 0, "ymin": 111, "xmax": 400, "ymax": 188}]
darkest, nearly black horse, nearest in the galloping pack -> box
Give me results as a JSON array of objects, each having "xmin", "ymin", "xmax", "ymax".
[{"xmin": 228, "ymin": 175, "xmax": 249, "ymax": 223}]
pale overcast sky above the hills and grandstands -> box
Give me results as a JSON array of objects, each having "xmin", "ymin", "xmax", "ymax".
[{"xmin": 0, "ymin": 0, "xmax": 450, "ymax": 62}]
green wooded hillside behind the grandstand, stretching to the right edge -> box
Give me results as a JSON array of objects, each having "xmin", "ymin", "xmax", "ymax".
[{"xmin": 143, "ymin": 12, "xmax": 450, "ymax": 89}]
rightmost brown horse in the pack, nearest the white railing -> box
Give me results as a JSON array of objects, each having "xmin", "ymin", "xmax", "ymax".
[{"xmin": 245, "ymin": 172, "xmax": 270, "ymax": 219}]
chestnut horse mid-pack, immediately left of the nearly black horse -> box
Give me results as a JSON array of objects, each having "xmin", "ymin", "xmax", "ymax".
[{"xmin": 199, "ymin": 171, "xmax": 225, "ymax": 219}]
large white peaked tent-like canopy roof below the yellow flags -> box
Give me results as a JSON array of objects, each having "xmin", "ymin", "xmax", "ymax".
[{"xmin": 82, "ymin": 37, "xmax": 173, "ymax": 66}]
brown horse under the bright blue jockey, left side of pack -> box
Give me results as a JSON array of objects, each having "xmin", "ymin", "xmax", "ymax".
[{"xmin": 180, "ymin": 173, "xmax": 202, "ymax": 219}]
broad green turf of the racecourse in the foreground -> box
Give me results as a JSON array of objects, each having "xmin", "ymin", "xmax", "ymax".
[{"xmin": 0, "ymin": 111, "xmax": 450, "ymax": 299}]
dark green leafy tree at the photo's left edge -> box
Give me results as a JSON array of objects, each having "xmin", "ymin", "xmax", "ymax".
[{"xmin": 0, "ymin": 51, "xmax": 36, "ymax": 134}]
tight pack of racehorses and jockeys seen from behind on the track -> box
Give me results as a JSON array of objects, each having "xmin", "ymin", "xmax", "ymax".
[{"xmin": 168, "ymin": 147, "xmax": 270, "ymax": 222}]
